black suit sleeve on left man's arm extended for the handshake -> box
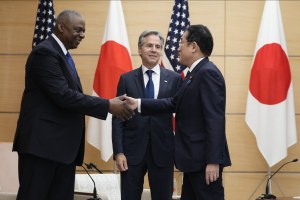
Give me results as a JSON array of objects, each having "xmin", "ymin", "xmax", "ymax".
[{"xmin": 26, "ymin": 48, "xmax": 109, "ymax": 119}]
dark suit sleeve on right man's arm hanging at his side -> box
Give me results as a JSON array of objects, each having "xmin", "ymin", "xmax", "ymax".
[{"xmin": 199, "ymin": 69, "xmax": 226, "ymax": 164}]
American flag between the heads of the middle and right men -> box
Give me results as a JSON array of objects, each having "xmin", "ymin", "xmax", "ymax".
[{"xmin": 162, "ymin": 0, "xmax": 190, "ymax": 73}]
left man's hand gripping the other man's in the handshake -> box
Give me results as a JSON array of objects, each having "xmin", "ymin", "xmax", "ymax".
[{"xmin": 109, "ymin": 95, "xmax": 134, "ymax": 120}]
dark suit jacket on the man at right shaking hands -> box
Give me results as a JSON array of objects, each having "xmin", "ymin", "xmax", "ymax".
[{"xmin": 141, "ymin": 58, "xmax": 231, "ymax": 172}]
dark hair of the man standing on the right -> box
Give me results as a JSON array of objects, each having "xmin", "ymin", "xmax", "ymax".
[{"xmin": 186, "ymin": 24, "xmax": 214, "ymax": 56}]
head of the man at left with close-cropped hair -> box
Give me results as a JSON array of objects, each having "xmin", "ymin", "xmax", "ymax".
[{"xmin": 58, "ymin": 11, "xmax": 85, "ymax": 49}]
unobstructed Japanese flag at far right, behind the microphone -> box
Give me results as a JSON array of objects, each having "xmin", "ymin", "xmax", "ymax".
[{"xmin": 246, "ymin": 1, "xmax": 297, "ymax": 167}]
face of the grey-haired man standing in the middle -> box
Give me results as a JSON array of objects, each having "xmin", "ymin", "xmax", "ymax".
[{"xmin": 139, "ymin": 35, "xmax": 162, "ymax": 69}]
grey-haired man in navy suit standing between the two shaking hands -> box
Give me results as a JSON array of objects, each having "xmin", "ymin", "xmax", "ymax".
[{"xmin": 112, "ymin": 30, "xmax": 182, "ymax": 200}]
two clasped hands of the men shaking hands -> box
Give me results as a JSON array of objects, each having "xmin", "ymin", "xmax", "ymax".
[{"xmin": 109, "ymin": 95, "xmax": 138, "ymax": 120}]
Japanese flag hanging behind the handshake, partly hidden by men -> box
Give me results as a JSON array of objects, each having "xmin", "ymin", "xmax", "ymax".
[{"xmin": 87, "ymin": 0, "xmax": 132, "ymax": 162}]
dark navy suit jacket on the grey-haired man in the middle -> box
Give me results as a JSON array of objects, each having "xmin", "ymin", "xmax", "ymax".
[{"xmin": 112, "ymin": 67, "xmax": 182, "ymax": 167}]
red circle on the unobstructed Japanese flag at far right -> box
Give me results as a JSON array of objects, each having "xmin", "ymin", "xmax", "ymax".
[{"xmin": 250, "ymin": 43, "xmax": 291, "ymax": 105}]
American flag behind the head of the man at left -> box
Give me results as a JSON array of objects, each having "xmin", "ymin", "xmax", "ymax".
[{"xmin": 32, "ymin": 0, "xmax": 55, "ymax": 48}]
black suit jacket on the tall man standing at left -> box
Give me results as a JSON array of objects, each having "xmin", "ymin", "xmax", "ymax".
[{"xmin": 13, "ymin": 37, "xmax": 109, "ymax": 165}]
